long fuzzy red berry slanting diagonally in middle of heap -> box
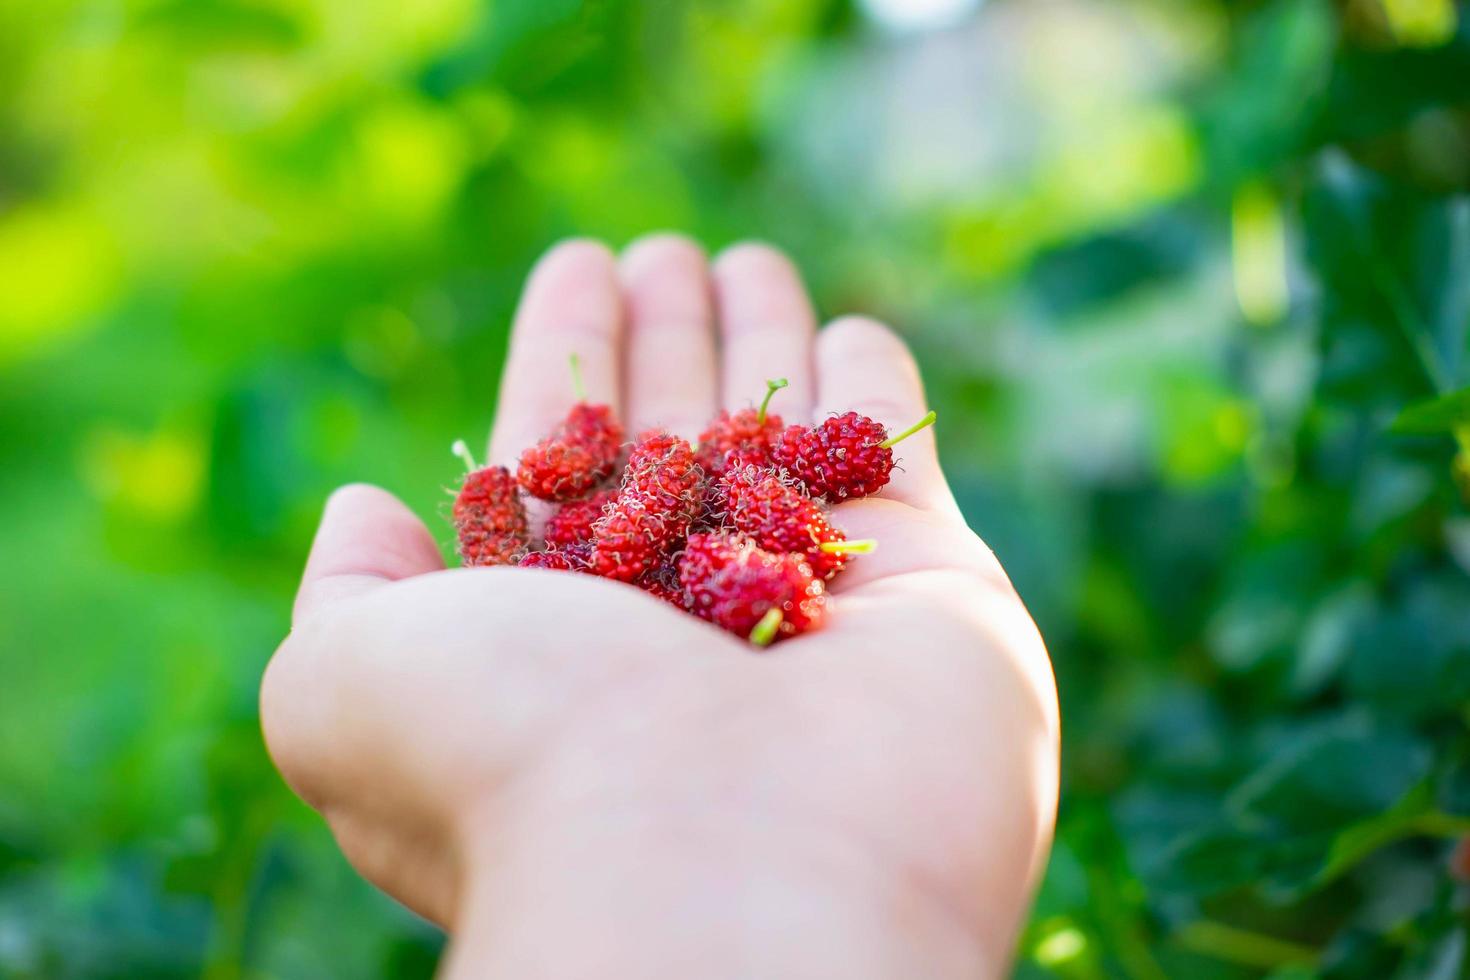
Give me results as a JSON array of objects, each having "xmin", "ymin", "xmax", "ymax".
[{"xmin": 592, "ymin": 432, "xmax": 704, "ymax": 582}]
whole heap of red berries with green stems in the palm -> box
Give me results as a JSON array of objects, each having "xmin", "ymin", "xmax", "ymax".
[{"xmin": 441, "ymin": 357, "xmax": 935, "ymax": 646}]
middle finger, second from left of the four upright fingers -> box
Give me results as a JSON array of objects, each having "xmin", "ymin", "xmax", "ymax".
[{"xmin": 619, "ymin": 235, "xmax": 719, "ymax": 439}]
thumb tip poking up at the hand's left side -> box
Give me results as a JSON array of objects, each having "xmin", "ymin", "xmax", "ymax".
[{"xmin": 291, "ymin": 483, "xmax": 444, "ymax": 623}]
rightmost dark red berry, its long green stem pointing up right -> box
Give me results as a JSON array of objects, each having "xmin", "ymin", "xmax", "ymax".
[{"xmin": 772, "ymin": 411, "xmax": 894, "ymax": 502}]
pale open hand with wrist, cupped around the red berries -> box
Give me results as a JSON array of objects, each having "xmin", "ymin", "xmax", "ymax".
[{"xmin": 262, "ymin": 235, "xmax": 1058, "ymax": 980}]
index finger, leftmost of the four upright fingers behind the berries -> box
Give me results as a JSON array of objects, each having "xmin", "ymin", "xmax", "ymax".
[{"xmin": 490, "ymin": 239, "xmax": 622, "ymax": 464}]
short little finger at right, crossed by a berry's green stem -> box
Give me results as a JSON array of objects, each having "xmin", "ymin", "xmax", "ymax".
[{"xmin": 816, "ymin": 316, "xmax": 954, "ymax": 510}]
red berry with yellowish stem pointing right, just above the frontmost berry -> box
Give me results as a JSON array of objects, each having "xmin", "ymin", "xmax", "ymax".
[{"xmin": 717, "ymin": 466, "xmax": 847, "ymax": 579}]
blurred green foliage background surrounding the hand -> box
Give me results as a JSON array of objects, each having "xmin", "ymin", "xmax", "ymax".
[{"xmin": 0, "ymin": 0, "xmax": 1470, "ymax": 980}]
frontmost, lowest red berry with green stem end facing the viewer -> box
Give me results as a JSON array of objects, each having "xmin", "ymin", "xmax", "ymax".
[{"xmin": 679, "ymin": 533, "xmax": 826, "ymax": 639}]
